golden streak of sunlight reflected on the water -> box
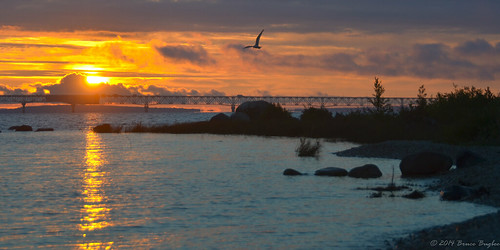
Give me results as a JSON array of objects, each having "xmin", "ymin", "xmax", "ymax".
[{"xmin": 79, "ymin": 131, "xmax": 113, "ymax": 249}]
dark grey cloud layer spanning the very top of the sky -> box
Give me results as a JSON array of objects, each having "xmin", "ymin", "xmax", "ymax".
[{"xmin": 0, "ymin": 0, "xmax": 500, "ymax": 33}]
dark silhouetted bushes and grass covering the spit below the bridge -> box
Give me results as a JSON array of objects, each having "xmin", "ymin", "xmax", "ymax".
[{"xmin": 93, "ymin": 78, "xmax": 500, "ymax": 145}]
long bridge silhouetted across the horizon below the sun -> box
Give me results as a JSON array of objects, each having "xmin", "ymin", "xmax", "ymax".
[{"xmin": 0, "ymin": 95, "xmax": 418, "ymax": 112}]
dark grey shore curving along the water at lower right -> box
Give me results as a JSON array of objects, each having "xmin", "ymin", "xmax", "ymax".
[{"xmin": 337, "ymin": 141, "xmax": 500, "ymax": 249}]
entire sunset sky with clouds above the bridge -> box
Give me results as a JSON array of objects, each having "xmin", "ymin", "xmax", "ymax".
[{"xmin": 0, "ymin": 0, "xmax": 500, "ymax": 97}]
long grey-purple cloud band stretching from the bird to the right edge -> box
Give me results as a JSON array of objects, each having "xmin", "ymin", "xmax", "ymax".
[{"xmin": 227, "ymin": 40, "xmax": 500, "ymax": 80}]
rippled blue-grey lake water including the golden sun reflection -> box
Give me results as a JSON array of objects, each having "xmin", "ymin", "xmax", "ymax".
[{"xmin": 0, "ymin": 113, "xmax": 496, "ymax": 249}]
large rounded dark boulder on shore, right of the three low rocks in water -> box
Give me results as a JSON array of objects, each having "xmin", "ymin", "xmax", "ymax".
[{"xmin": 399, "ymin": 152, "xmax": 453, "ymax": 177}]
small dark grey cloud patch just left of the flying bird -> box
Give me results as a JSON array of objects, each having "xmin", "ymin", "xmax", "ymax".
[{"xmin": 156, "ymin": 45, "xmax": 215, "ymax": 65}]
